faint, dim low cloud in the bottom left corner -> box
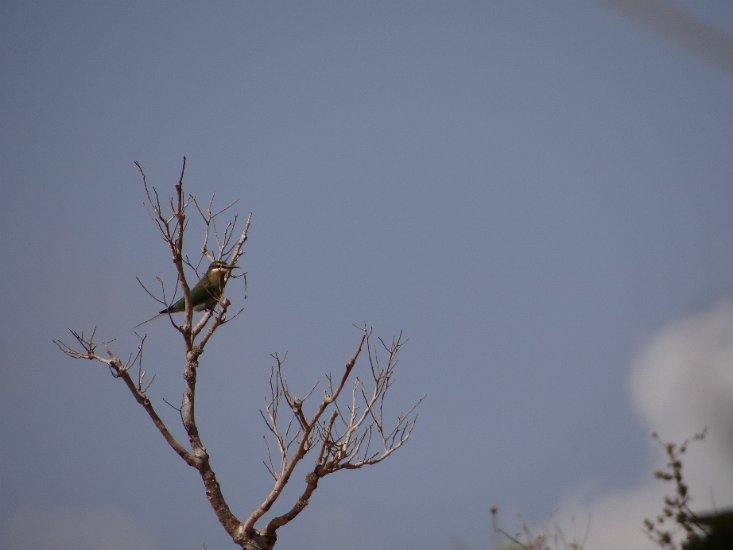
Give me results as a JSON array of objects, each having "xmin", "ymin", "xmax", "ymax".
[{"xmin": 0, "ymin": 507, "xmax": 157, "ymax": 550}]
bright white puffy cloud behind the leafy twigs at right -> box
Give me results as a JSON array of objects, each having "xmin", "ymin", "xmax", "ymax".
[{"xmin": 555, "ymin": 300, "xmax": 733, "ymax": 550}]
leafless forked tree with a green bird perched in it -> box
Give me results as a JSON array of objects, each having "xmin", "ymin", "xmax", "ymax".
[{"xmin": 54, "ymin": 157, "xmax": 422, "ymax": 550}]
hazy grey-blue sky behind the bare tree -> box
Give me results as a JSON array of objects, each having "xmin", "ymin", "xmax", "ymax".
[{"xmin": 0, "ymin": 0, "xmax": 733, "ymax": 550}]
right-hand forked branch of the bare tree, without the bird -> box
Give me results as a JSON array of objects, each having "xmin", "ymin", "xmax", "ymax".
[{"xmin": 245, "ymin": 326, "xmax": 423, "ymax": 534}]
